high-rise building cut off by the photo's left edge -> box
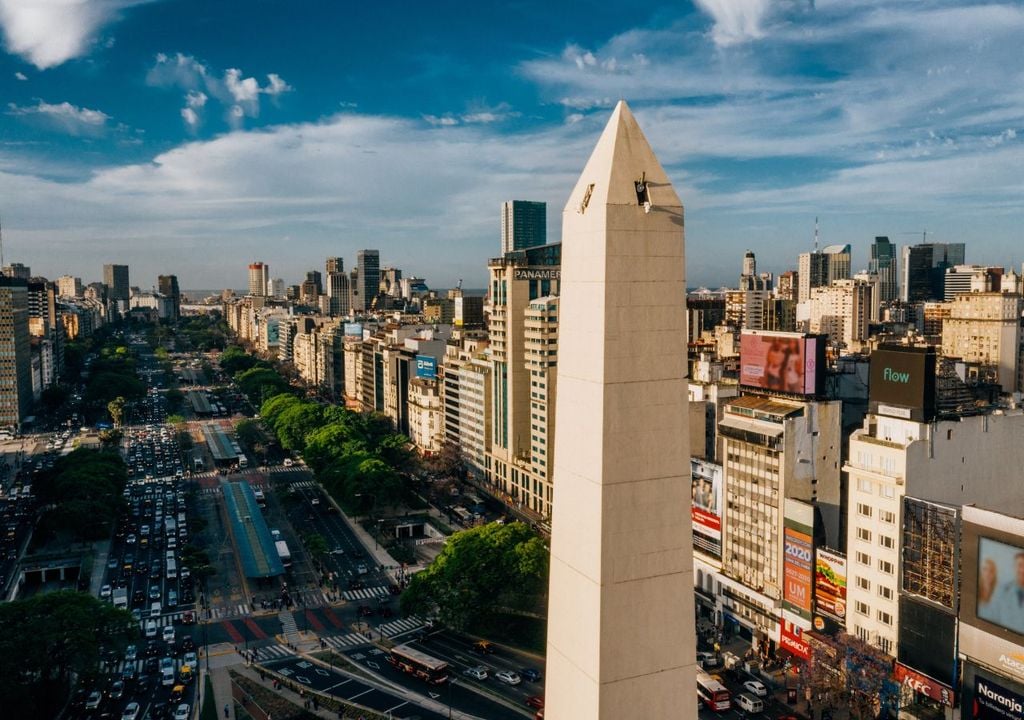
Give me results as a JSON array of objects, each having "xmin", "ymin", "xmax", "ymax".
[{"xmin": 0, "ymin": 276, "xmax": 32, "ymax": 427}]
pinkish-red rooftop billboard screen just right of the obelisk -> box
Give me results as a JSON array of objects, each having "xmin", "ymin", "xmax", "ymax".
[{"xmin": 739, "ymin": 331, "xmax": 825, "ymax": 395}]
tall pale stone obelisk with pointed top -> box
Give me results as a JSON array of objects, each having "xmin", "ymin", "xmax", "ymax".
[{"xmin": 545, "ymin": 101, "xmax": 696, "ymax": 720}]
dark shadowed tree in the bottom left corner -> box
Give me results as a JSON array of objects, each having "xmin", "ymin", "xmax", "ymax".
[{"xmin": 0, "ymin": 590, "xmax": 138, "ymax": 718}]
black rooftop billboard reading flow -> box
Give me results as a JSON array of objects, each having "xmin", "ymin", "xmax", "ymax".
[{"xmin": 867, "ymin": 345, "xmax": 936, "ymax": 422}]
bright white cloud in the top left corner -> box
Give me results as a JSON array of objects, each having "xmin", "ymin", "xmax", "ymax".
[{"xmin": 0, "ymin": 0, "xmax": 147, "ymax": 70}]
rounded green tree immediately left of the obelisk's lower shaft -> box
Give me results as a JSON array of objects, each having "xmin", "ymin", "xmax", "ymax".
[{"xmin": 401, "ymin": 522, "xmax": 549, "ymax": 629}]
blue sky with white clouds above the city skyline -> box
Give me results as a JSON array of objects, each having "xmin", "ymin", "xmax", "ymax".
[{"xmin": 0, "ymin": 0, "xmax": 1024, "ymax": 288}]
